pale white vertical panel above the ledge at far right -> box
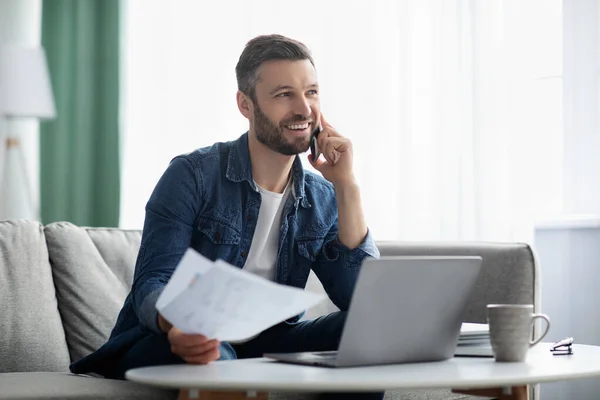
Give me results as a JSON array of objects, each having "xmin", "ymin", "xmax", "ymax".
[{"xmin": 563, "ymin": 0, "xmax": 600, "ymax": 216}]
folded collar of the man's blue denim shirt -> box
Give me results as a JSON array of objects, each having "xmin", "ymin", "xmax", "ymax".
[{"xmin": 225, "ymin": 132, "xmax": 311, "ymax": 208}]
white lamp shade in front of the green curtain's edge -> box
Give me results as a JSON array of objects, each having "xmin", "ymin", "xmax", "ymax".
[{"xmin": 0, "ymin": 45, "xmax": 56, "ymax": 119}]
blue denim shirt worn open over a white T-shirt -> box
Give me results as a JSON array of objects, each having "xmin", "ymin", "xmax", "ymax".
[{"xmin": 71, "ymin": 133, "xmax": 379, "ymax": 374}]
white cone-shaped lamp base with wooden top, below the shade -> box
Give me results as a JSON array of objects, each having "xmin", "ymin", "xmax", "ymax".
[{"xmin": 0, "ymin": 118, "xmax": 39, "ymax": 220}]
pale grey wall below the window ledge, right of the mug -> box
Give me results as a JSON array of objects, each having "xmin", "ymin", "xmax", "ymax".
[{"xmin": 535, "ymin": 217, "xmax": 600, "ymax": 400}]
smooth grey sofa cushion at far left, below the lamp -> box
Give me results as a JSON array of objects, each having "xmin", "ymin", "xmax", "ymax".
[{"xmin": 0, "ymin": 220, "xmax": 69, "ymax": 372}]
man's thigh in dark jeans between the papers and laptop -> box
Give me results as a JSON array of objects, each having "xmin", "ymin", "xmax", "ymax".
[{"xmin": 236, "ymin": 311, "xmax": 347, "ymax": 358}]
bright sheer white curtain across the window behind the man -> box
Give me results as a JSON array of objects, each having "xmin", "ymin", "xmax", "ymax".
[{"xmin": 121, "ymin": 0, "xmax": 562, "ymax": 241}]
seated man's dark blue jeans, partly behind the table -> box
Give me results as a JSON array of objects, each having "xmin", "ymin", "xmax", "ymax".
[{"xmin": 112, "ymin": 312, "xmax": 384, "ymax": 400}]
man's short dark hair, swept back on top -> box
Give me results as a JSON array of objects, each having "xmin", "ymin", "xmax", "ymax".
[{"xmin": 235, "ymin": 35, "xmax": 315, "ymax": 101}]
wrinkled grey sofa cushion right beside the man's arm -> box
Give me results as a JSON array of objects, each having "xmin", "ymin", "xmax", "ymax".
[{"xmin": 45, "ymin": 222, "xmax": 141, "ymax": 361}]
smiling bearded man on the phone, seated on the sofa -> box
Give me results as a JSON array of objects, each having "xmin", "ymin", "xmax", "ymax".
[{"xmin": 71, "ymin": 35, "xmax": 382, "ymax": 399}]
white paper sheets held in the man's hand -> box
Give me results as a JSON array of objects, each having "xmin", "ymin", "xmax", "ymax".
[{"xmin": 156, "ymin": 249, "xmax": 325, "ymax": 341}]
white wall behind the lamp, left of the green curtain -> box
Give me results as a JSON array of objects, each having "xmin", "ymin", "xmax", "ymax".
[{"xmin": 0, "ymin": 0, "xmax": 42, "ymax": 219}]
